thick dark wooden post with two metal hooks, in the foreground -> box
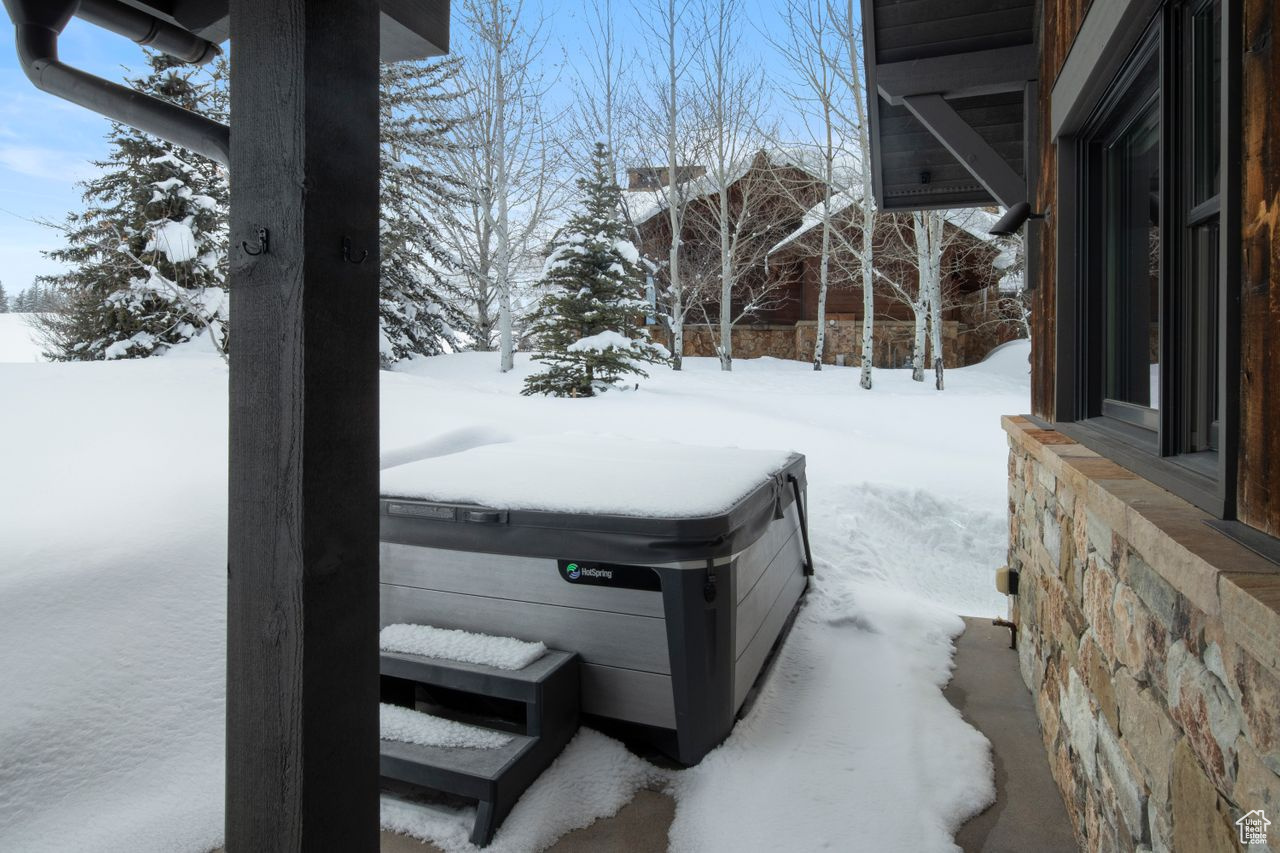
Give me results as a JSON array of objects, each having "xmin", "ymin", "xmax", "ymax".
[{"xmin": 227, "ymin": 0, "xmax": 379, "ymax": 853}]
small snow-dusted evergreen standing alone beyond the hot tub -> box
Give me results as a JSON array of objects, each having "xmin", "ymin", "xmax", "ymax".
[{"xmin": 524, "ymin": 143, "xmax": 671, "ymax": 397}]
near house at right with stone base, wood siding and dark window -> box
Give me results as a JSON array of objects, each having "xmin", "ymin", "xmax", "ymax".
[{"xmin": 863, "ymin": 0, "xmax": 1280, "ymax": 850}]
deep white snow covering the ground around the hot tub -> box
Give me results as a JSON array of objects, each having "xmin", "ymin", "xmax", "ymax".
[{"xmin": 0, "ymin": 333, "xmax": 1028, "ymax": 852}]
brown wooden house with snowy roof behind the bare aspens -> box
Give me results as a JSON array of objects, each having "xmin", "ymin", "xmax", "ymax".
[{"xmin": 626, "ymin": 151, "xmax": 1024, "ymax": 368}]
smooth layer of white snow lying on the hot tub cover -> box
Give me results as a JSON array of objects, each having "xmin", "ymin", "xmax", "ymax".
[{"xmin": 381, "ymin": 433, "xmax": 792, "ymax": 517}]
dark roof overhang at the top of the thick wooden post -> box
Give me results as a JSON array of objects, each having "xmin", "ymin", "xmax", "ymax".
[{"xmin": 120, "ymin": 0, "xmax": 449, "ymax": 63}]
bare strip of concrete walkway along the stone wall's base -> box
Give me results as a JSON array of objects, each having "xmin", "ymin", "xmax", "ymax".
[{"xmin": 943, "ymin": 619, "xmax": 1079, "ymax": 853}]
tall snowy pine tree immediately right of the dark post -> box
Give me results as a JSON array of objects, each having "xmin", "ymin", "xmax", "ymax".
[{"xmin": 379, "ymin": 59, "xmax": 475, "ymax": 366}]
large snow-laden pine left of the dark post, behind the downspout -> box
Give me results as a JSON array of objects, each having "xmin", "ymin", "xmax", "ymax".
[{"xmin": 38, "ymin": 51, "xmax": 228, "ymax": 361}]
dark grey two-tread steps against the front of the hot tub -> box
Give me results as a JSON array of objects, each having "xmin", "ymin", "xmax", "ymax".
[{"xmin": 380, "ymin": 649, "xmax": 579, "ymax": 847}]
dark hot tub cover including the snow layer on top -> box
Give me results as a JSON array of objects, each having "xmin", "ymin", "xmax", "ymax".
[{"xmin": 380, "ymin": 433, "xmax": 804, "ymax": 562}]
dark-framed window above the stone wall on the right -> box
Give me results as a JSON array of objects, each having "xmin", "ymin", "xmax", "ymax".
[{"xmin": 1068, "ymin": 0, "xmax": 1225, "ymax": 506}]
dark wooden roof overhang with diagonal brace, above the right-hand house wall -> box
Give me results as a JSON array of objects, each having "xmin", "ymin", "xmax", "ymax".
[{"xmin": 861, "ymin": 0, "xmax": 1038, "ymax": 210}]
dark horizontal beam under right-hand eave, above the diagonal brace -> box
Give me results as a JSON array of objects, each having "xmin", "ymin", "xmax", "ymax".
[{"xmin": 876, "ymin": 45, "xmax": 1039, "ymax": 106}]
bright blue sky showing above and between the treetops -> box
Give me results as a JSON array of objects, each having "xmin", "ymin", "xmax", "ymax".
[{"xmin": 0, "ymin": 0, "xmax": 834, "ymax": 295}]
